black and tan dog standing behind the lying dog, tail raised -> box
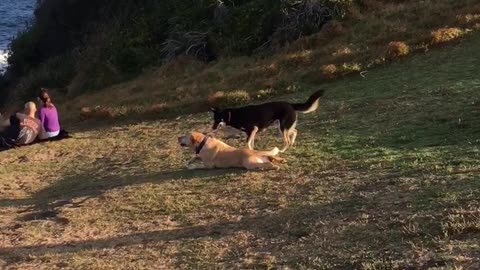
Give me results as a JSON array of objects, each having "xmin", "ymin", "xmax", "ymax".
[{"xmin": 211, "ymin": 90, "xmax": 325, "ymax": 152}]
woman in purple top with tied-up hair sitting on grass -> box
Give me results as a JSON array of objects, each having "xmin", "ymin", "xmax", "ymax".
[{"xmin": 38, "ymin": 88, "xmax": 60, "ymax": 138}]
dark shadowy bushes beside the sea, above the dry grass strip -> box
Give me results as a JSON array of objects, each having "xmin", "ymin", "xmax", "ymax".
[{"xmin": 0, "ymin": 0, "xmax": 349, "ymax": 104}]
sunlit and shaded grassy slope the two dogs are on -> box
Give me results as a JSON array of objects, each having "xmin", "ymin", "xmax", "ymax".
[{"xmin": 0, "ymin": 34, "xmax": 480, "ymax": 269}]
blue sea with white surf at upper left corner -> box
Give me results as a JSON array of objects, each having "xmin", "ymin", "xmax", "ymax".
[{"xmin": 0, "ymin": 0, "xmax": 37, "ymax": 72}]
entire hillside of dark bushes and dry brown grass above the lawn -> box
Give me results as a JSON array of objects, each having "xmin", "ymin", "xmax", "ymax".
[{"xmin": 0, "ymin": 0, "xmax": 480, "ymax": 115}]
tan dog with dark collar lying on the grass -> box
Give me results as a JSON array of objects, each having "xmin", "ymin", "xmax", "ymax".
[{"xmin": 178, "ymin": 132, "xmax": 284, "ymax": 170}]
